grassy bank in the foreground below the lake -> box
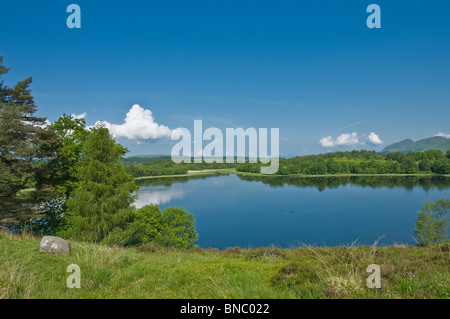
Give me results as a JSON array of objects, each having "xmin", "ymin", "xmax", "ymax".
[{"xmin": 0, "ymin": 233, "xmax": 450, "ymax": 299}]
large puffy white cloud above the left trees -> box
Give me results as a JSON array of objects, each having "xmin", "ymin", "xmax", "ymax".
[{"xmin": 95, "ymin": 104, "xmax": 172, "ymax": 143}]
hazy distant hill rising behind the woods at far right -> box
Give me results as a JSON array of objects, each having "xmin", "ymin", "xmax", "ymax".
[{"xmin": 381, "ymin": 136, "xmax": 450, "ymax": 154}]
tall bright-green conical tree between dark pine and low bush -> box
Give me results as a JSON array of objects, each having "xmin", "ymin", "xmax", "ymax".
[{"xmin": 62, "ymin": 127, "xmax": 138, "ymax": 243}]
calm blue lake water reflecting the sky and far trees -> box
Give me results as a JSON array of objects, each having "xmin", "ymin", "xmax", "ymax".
[{"xmin": 136, "ymin": 175, "xmax": 450, "ymax": 249}]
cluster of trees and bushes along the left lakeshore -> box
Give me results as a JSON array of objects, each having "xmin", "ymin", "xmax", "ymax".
[{"xmin": 0, "ymin": 56, "xmax": 198, "ymax": 248}]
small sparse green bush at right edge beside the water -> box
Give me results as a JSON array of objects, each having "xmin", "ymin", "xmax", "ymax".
[{"xmin": 415, "ymin": 199, "xmax": 450, "ymax": 246}]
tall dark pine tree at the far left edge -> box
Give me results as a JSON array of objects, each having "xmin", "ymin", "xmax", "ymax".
[{"xmin": 0, "ymin": 57, "xmax": 54, "ymax": 227}]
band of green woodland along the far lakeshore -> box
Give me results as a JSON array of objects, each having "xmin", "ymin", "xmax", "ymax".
[{"xmin": 124, "ymin": 150, "xmax": 450, "ymax": 178}]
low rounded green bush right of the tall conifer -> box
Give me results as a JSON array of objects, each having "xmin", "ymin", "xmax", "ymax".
[{"xmin": 126, "ymin": 205, "xmax": 198, "ymax": 248}]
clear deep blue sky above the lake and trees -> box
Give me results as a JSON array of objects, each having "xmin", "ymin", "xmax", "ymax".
[{"xmin": 0, "ymin": 0, "xmax": 450, "ymax": 156}]
